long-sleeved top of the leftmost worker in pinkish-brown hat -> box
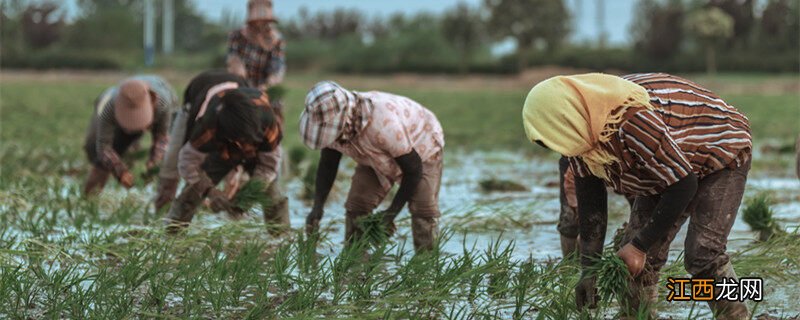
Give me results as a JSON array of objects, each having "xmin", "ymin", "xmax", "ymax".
[{"xmin": 84, "ymin": 75, "xmax": 178, "ymax": 178}]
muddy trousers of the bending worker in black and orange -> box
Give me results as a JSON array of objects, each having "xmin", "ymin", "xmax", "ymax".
[{"xmin": 167, "ymin": 154, "xmax": 289, "ymax": 232}]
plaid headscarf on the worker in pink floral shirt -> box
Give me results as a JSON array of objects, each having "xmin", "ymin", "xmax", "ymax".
[{"xmin": 300, "ymin": 81, "xmax": 374, "ymax": 149}]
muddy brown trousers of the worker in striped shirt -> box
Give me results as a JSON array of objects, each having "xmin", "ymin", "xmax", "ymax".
[{"xmin": 621, "ymin": 161, "xmax": 750, "ymax": 319}]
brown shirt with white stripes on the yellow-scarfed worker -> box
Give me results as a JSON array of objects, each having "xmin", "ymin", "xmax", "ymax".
[{"xmin": 570, "ymin": 73, "xmax": 752, "ymax": 196}]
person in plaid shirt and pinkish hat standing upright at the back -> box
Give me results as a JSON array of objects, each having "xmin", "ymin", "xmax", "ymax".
[{"xmin": 227, "ymin": 0, "xmax": 286, "ymax": 91}]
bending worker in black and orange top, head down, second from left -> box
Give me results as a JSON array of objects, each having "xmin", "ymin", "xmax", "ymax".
[{"xmin": 156, "ymin": 71, "xmax": 289, "ymax": 232}]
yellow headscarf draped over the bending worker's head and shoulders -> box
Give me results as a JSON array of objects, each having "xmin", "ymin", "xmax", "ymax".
[{"xmin": 522, "ymin": 73, "xmax": 653, "ymax": 180}]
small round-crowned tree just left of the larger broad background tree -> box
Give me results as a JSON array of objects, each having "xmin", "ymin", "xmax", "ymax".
[{"xmin": 442, "ymin": 2, "xmax": 485, "ymax": 73}]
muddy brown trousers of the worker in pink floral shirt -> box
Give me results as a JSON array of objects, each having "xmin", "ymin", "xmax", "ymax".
[{"xmin": 344, "ymin": 157, "xmax": 442, "ymax": 252}]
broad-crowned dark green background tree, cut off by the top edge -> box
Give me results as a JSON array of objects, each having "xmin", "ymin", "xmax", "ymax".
[{"xmin": 484, "ymin": 0, "xmax": 570, "ymax": 69}]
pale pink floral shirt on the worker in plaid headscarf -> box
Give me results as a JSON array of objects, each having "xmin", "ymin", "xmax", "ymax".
[{"xmin": 331, "ymin": 91, "xmax": 444, "ymax": 189}]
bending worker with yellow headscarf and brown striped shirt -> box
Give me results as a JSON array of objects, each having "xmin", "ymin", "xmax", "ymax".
[{"xmin": 522, "ymin": 73, "xmax": 752, "ymax": 319}]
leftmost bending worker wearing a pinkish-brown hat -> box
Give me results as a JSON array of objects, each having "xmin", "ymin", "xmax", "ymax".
[{"xmin": 83, "ymin": 75, "xmax": 178, "ymax": 194}]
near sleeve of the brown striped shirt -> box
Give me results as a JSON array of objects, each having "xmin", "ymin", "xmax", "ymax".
[{"xmin": 620, "ymin": 111, "xmax": 692, "ymax": 185}]
